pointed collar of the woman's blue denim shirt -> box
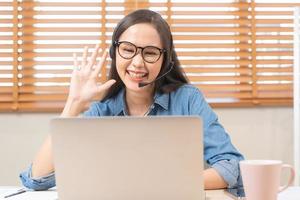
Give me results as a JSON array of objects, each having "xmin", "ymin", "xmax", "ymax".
[{"xmin": 114, "ymin": 88, "xmax": 170, "ymax": 115}]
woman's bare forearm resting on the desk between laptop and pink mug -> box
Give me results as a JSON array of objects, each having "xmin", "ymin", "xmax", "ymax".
[{"xmin": 204, "ymin": 168, "xmax": 227, "ymax": 190}]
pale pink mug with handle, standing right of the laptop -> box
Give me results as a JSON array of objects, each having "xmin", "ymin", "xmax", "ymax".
[{"xmin": 240, "ymin": 160, "xmax": 295, "ymax": 200}]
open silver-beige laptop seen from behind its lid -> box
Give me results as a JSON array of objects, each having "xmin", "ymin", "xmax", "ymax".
[{"xmin": 50, "ymin": 116, "xmax": 205, "ymax": 200}]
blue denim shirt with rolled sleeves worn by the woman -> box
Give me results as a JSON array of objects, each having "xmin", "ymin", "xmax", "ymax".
[{"xmin": 20, "ymin": 84, "xmax": 244, "ymax": 190}]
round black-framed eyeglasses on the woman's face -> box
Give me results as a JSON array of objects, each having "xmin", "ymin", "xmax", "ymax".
[{"xmin": 115, "ymin": 41, "xmax": 166, "ymax": 63}]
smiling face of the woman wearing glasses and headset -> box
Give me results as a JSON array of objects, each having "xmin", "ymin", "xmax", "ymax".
[{"xmin": 116, "ymin": 23, "xmax": 163, "ymax": 92}]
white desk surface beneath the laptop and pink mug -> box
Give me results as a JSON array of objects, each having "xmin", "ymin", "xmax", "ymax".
[{"xmin": 0, "ymin": 186, "xmax": 300, "ymax": 200}]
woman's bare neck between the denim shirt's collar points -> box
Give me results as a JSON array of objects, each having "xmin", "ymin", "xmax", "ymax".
[{"xmin": 126, "ymin": 88, "xmax": 153, "ymax": 116}]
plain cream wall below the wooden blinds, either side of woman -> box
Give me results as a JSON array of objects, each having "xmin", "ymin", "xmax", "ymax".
[{"xmin": 0, "ymin": 107, "xmax": 293, "ymax": 185}]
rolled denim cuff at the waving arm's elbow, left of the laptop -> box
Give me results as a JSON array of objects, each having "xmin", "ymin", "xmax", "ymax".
[{"xmin": 20, "ymin": 165, "xmax": 55, "ymax": 190}]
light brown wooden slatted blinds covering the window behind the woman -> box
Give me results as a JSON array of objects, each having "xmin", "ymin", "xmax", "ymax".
[{"xmin": 0, "ymin": 0, "xmax": 300, "ymax": 111}]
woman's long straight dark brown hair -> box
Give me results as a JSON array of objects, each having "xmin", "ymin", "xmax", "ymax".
[{"xmin": 104, "ymin": 9, "xmax": 188, "ymax": 99}]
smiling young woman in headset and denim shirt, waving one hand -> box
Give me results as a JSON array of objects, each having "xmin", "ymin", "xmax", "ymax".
[{"xmin": 20, "ymin": 10, "xmax": 243, "ymax": 190}]
